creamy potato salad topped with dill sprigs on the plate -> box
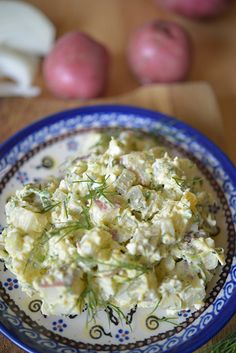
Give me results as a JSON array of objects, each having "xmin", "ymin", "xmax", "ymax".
[{"xmin": 0, "ymin": 131, "xmax": 224, "ymax": 315}]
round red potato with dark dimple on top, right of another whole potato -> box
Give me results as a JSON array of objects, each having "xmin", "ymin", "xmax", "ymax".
[{"xmin": 128, "ymin": 20, "xmax": 191, "ymax": 84}]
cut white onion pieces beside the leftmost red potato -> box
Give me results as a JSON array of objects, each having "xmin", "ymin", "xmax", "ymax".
[{"xmin": 0, "ymin": 0, "xmax": 55, "ymax": 97}]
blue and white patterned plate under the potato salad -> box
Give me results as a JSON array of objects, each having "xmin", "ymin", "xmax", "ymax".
[{"xmin": 0, "ymin": 105, "xmax": 236, "ymax": 353}]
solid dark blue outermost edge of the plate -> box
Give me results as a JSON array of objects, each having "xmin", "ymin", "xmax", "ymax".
[{"xmin": 0, "ymin": 104, "xmax": 236, "ymax": 353}]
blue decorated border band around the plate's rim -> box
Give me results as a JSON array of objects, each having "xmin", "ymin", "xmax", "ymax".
[{"xmin": 0, "ymin": 105, "xmax": 236, "ymax": 353}]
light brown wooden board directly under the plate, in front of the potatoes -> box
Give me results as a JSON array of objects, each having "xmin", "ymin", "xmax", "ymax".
[{"xmin": 0, "ymin": 82, "xmax": 236, "ymax": 353}]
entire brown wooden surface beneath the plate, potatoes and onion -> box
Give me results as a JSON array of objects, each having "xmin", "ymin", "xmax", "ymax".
[{"xmin": 0, "ymin": 0, "xmax": 236, "ymax": 353}]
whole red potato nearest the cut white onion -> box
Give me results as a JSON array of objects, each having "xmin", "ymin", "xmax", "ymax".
[{"xmin": 43, "ymin": 32, "xmax": 109, "ymax": 99}]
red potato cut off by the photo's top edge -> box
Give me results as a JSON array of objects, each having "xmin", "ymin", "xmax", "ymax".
[{"xmin": 156, "ymin": 0, "xmax": 232, "ymax": 18}]
